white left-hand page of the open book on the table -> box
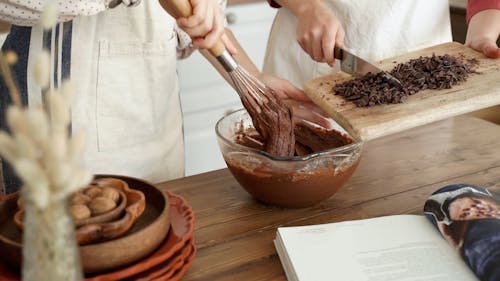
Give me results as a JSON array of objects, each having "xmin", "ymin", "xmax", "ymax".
[{"xmin": 276, "ymin": 215, "xmax": 478, "ymax": 281}]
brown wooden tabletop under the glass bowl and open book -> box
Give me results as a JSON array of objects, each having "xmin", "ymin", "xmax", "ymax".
[{"xmin": 159, "ymin": 117, "xmax": 500, "ymax": 281}]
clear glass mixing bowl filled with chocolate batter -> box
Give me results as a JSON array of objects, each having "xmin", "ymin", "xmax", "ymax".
[{"xmin": 215, "ymin": 109, "xmax": 363, "ymax": 207}]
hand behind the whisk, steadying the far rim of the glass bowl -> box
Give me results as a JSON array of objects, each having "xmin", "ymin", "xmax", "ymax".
[{"xmin": 261, "ymin": 75, "xmax": 332, "ymax": 129}]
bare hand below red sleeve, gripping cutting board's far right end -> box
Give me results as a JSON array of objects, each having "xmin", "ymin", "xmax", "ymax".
[{"xmin": 465, "ymin": 10, "xmax": 500, "ymax": 59}]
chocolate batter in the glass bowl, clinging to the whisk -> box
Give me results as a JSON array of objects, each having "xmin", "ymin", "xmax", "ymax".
[{"xmin": 230, "ymin": 78, "xmax": 360, "ymax": 207}]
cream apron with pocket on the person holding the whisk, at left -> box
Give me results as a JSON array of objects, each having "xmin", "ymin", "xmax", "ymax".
[{"xmin": 26, "ymin": 0, "xmax": 184, "ymax": 183}]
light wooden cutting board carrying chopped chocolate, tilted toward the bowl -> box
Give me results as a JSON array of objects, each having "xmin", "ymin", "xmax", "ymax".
[{"xmin": 304, "ymin": 42, "xmax": 500, "ymax": 141}]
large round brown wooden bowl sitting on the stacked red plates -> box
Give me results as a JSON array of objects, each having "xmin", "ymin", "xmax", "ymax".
[{"xmin": 0, "ymin": 175, "xmax": 170, "ymax": 274}]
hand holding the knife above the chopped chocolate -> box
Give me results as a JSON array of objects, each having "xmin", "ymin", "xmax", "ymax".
[{"xmin": 270, "ymin": 0, "xmax": 345, "ymax": 66}]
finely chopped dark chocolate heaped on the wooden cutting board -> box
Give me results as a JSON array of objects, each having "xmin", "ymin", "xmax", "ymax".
[{"xmin": 332, "ymin": 55, "xmax": 477, "ymax": 107}]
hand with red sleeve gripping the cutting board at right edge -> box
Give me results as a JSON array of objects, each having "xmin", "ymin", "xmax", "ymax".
[{"xmin": 465, "ymin": 0, "xmax": 500, "ymax": 58}]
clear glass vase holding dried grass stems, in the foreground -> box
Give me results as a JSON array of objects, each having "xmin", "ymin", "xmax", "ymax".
[{"xmin": 22, "ymin": 194, "xmax": 83, "ymax": 281}]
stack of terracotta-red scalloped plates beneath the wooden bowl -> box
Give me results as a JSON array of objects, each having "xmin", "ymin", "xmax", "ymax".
[{"xmin": 0, "ymin": 191, "xmax": 196, "ymax": 281}]
